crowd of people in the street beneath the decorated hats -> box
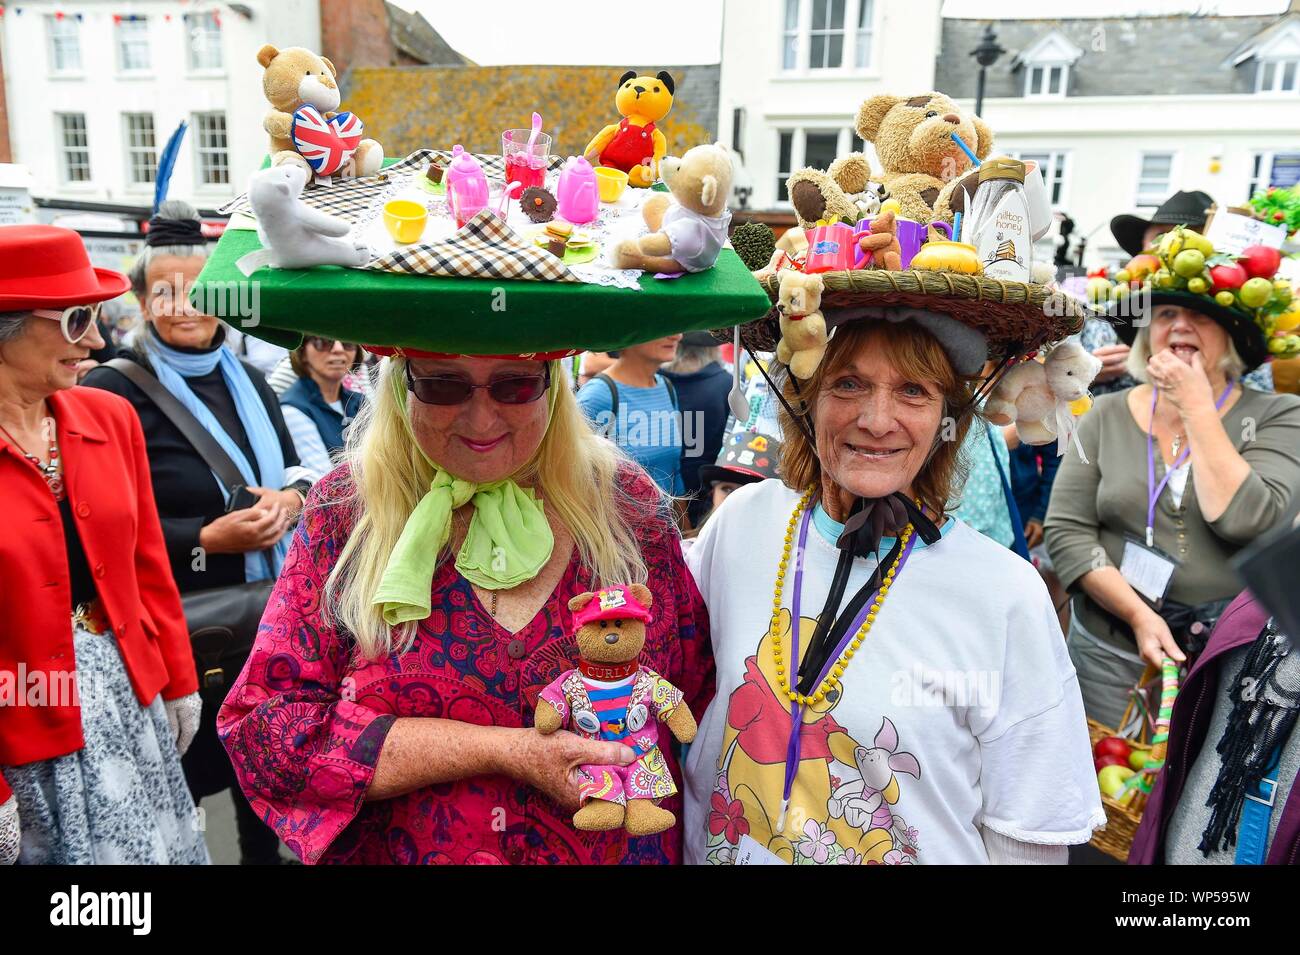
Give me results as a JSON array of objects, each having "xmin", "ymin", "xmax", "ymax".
[{"xmin": 0, "ymin": 183, "xmax": 1300, "ymax": 864}]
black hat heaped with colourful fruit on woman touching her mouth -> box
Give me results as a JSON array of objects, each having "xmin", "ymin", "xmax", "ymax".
[{"xmin": 1088, "ymin": 226, "xmax": 1300, "ymax": 370}]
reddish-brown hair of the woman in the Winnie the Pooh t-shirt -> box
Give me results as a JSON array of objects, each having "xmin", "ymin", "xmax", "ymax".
[{"xmin": 780, "ymin": 321, "xmax": 975, "ymax": 516}]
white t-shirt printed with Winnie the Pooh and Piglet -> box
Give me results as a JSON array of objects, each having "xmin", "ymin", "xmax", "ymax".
[{"xmin": 684, "ymin": 481, "xmax": 1105, "ymax": 864}]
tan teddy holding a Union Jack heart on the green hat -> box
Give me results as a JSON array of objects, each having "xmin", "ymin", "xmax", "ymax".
[{"xmin": 257, "ymin": 43, "xmax": 384, "ymax": 178}]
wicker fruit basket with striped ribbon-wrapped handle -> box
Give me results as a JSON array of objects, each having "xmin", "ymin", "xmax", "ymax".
[{"xmin": 1088, "ymin": 659, "xmax": 1178, "ymax": 861}]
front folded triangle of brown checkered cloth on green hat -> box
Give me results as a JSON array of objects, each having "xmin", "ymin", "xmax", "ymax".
[{"xmin": 365, "ymin": 209, "xmax": 581, "ymax": 282}]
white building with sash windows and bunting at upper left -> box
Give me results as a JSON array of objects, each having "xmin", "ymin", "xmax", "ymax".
[{"xmin": 0, "ymin": 0, "xmax": 320, "ymax": 208}]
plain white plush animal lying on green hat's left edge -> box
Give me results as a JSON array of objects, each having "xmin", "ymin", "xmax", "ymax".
[{"xmin": 237, "ymin": 164, "xmax": 371, "ymax": 275}]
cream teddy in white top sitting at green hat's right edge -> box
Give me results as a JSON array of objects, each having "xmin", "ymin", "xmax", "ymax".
[{"xmin": 612, "ymin": 143, "xmax": 732, "ymax": 273}]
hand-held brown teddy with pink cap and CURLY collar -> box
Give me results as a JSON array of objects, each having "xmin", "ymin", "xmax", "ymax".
[{"xmin": 533, "ymin": 583, "xmax": 698, "ymax": 835}]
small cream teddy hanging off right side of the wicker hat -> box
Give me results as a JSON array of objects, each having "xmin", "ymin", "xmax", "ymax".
[{"xmin": 984, "ymin": 339, "xmax": 1101, "ymax": 455}]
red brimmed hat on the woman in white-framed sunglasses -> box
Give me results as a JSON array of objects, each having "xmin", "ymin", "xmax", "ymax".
[{"xmin": 0, "ymin": 225, "xmax": 131, "ymax": 312}]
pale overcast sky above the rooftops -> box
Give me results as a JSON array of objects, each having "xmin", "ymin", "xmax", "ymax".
[{"xmin": 395, "ymin": 0, "xmax": 1287, "ymax": 66}]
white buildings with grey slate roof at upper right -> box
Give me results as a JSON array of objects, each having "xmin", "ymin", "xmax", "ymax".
[{"xmin": 719, "ymin": 0, "xmax": 1300, "ymax": 266}]
